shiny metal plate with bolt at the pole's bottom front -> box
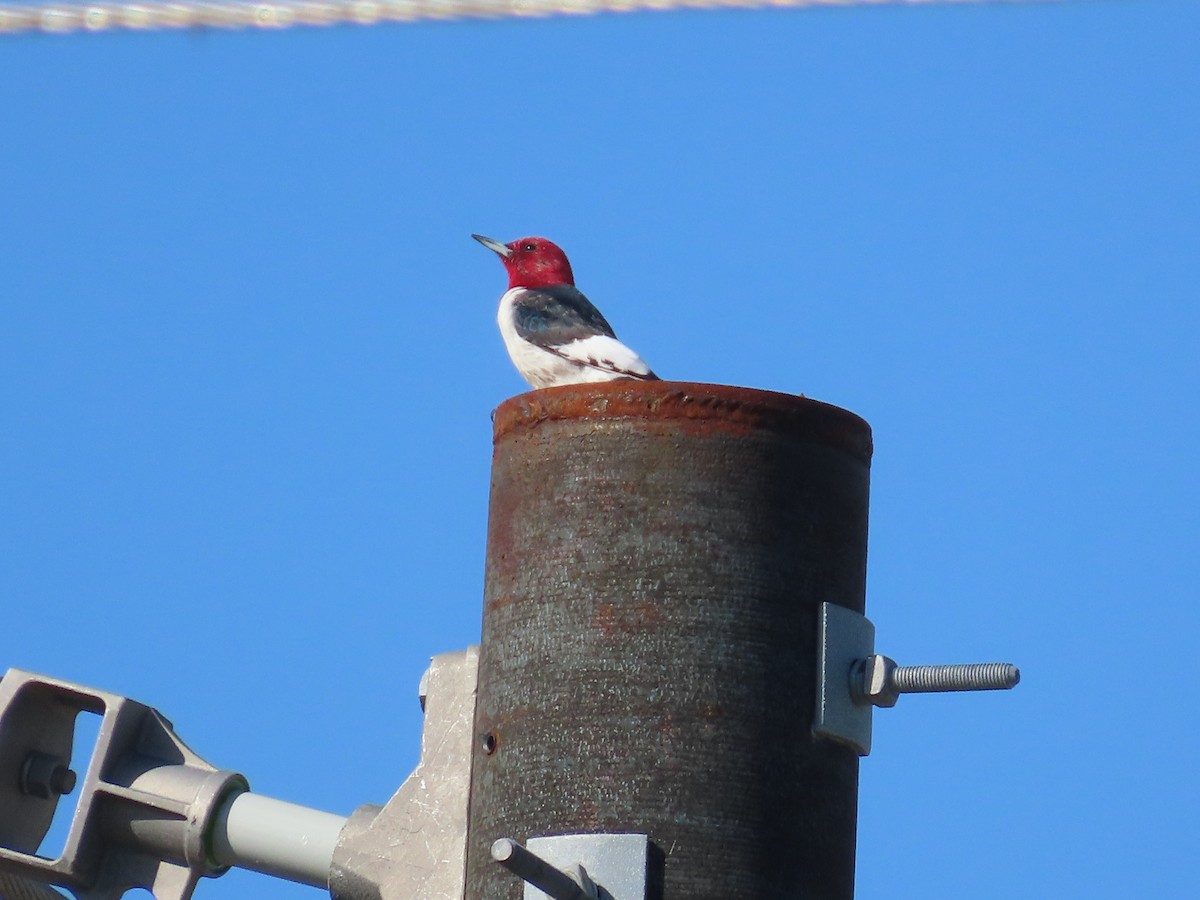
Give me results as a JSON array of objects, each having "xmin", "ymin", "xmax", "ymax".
[{"xmin": 492, "ymin": 834, "xmax": 649, "ymax": 900}]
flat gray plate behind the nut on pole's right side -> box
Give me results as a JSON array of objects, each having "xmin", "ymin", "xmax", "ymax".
[{"xmin": 812, "ymin": 604, "xmax": 875, "ymax": 756}]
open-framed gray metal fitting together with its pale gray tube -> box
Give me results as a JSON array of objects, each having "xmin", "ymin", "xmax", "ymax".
[{"xmin": 0, "ymin": 670, "xmax": 360, "ymax": 900}]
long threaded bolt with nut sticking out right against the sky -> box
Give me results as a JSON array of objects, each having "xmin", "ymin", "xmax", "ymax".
[{"xmin": 850, "ymin": 654, "xmax": 1021, "ymax": 707}]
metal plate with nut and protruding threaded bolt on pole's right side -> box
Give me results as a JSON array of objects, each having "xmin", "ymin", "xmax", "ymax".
[{"xmin": 812, "ymin": 604, "xmax": 1021, "ymax": 756}]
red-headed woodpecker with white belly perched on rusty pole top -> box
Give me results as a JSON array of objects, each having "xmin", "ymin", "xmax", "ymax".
[{"xmin": 470, "ymin": 234, "xmax": 659, "ymax": 389}]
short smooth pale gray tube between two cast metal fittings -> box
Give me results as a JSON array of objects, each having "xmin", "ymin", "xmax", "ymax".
[{"xmin": 211, "ymin": 792, "xmax": 347, "ymax": 888}]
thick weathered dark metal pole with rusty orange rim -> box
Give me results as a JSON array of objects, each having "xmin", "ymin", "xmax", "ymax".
[{"xmin": 466, "ymin": 382, "xmax": 871, "ymax": 900}]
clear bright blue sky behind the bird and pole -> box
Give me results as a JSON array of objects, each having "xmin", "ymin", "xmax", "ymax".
[{"xmin": 0, "ymin": 0, "xmax": 1200, "ymax": 900}]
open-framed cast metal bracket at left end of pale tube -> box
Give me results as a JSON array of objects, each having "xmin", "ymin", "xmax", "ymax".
[{"xmin": 0, "ymin": 668, "xmax": 248, "ymax": 900}]
